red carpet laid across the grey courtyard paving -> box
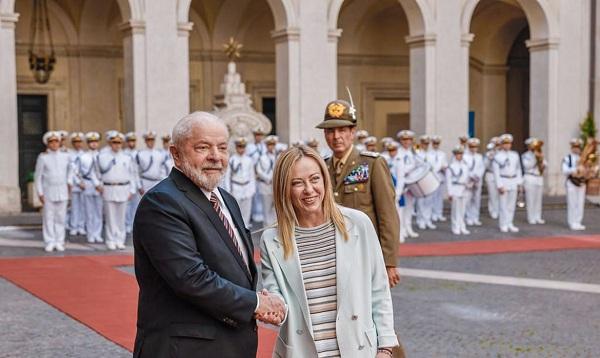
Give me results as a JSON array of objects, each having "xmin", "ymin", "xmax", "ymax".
[{"xmin": 0, "ymin": 235, "xmax": 600, "ymax": 358}]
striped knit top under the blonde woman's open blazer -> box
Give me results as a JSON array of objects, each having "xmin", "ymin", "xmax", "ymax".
[{"xmin": 294, "ymin": 221, "xmax": 340, "ymax": 358}]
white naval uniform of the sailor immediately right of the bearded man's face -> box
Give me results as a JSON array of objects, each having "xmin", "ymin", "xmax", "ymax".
[{"xmin": 223, "ymin": 153, "xmax": 256, "ymax": 227}]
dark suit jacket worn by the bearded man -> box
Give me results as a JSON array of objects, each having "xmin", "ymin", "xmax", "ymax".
[{"xmin": 133, "ymin": 168, "xmax": 257, "ymax": 358}]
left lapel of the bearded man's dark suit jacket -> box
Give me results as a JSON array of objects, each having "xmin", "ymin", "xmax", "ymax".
[{"xmin": 171, "ymin": 170, "xmax": 253, "ymax": 284}]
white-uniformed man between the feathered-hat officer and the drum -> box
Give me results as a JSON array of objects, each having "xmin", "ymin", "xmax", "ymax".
[{"xmin": 396, "ymin": 130, "xmax": 419, "ymax": 238}]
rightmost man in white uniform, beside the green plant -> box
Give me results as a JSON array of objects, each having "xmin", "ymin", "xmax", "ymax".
[{"xmin": 562, "ymin": 138, "xmax": 586, "ymax": 231}]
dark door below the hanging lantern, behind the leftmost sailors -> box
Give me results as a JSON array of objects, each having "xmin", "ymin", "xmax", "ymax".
[{"xmin": 17, "ymin": 95, "xmax": 48, "ymax": 211}]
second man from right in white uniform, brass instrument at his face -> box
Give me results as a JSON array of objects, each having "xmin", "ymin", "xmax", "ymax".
[{"xmin": 521, "ymin": 137, "xmax": 548, "ymax": 225}]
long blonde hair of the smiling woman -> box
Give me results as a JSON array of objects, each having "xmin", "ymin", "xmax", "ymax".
[{"xmin": 273, "ymin": 145, "xmax": 348, "ymax": 259}]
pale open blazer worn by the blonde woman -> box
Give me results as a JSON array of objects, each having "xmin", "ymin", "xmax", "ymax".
[{"xmin": 260, "ymin": 206, "xmax": 398, "ymax": 358}]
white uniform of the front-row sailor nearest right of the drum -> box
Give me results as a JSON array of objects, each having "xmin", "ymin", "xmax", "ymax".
[{"xmin": 446, "ymin": 158, "xmax": 470, "ymax": 235}]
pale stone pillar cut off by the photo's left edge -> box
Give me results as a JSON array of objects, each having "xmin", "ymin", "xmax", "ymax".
[{"xmin": 0, "ymin": 13, "xmax": 21, "ymax": 214}]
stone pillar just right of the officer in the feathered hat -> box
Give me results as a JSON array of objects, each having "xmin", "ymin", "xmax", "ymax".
[{"xmin": 406, "ymin": 34, "xmax": 437, "ymax": 133}]
